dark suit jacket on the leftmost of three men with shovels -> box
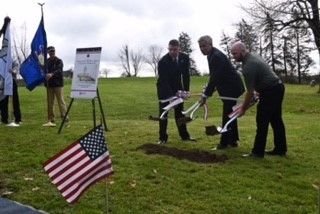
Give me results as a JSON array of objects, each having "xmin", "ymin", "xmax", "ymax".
[{"xmin": 157, "ymin": 52, "xmax": 190, "ymax": 100}]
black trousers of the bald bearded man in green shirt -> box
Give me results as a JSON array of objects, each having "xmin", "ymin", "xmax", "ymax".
[{"xmin": 252, "ymin": 84, "xmax": 287, "ymax": 156}]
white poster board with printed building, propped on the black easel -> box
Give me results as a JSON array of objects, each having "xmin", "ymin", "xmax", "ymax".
[{"xmin": 71, "ymin": 47, "xmax": 101, "ymax": 99}]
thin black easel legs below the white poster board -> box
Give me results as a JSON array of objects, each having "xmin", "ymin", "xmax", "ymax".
[{"xmin": 58, "ymin": 88, "xmax": 108, "ymax": 134}]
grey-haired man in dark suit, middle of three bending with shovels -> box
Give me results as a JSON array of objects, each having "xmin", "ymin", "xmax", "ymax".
[{"xmin": 198, "ymin": 36, "xmax": 244, "ymax": 149}]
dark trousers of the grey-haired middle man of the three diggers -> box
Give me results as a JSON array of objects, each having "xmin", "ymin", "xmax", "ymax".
[{"xmin": 220, "ymin": 100, "xmax": 239, "ymax": 146}]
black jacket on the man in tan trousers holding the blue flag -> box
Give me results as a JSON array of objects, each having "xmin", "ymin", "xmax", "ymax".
[{"xmin": 46, "ymin": 57, "xmax": 63, "ymax": 87}]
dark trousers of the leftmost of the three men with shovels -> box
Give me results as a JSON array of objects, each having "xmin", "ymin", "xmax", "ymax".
[{"xmin": 159, "ymin": 102, "xmax": 190, "ymax": 141}]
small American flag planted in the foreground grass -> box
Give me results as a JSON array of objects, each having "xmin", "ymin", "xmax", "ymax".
[{"xmin": 43, "ymin": 125, "xmax": 113, "ymax": 203}]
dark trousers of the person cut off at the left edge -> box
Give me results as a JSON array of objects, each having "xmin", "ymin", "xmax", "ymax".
[{"xmin": 0, "ymin": 80, "xmax": 21, "ymax": 123}]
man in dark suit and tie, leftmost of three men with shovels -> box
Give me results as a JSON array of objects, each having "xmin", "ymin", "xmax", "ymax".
[{"xmin": 157, "ymin": 39, "xmax": 195, "ymax": 144}]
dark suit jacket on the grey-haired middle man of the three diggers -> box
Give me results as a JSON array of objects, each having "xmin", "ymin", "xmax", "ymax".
[{"xmin": 204, "ymin": 48, "xmax": 244, "ymax": 97}]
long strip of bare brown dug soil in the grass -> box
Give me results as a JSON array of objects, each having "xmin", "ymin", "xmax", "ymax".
[{"xmin": 137, "ymin": 143, "xmax": 228, "ymax": 163}]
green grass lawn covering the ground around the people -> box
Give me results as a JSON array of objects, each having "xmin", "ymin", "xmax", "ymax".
[{"xmin": 0, "ymin": 77, "xmax": 320, "ymax": 213}]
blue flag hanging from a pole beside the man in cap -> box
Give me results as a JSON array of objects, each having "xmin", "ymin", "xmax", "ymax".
[{"xmin": 20, "ymin": 14, "xmax": 47, "ymax": 91}]
